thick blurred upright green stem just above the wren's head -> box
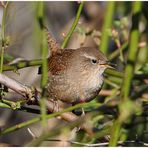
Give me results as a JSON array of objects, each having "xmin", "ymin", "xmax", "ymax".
[{"xmin": 100, "ymin": 1, "xmax": 115, "ymax": 54}]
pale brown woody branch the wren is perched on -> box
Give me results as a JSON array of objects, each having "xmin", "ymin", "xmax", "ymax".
[{"xmin": 0, "ymin": 74, "xmax": 93, "ymax": 135}]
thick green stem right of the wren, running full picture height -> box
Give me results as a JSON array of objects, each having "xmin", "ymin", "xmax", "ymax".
[{"xmin": 109, "ymin": 1, "xmax": 141, "ymax": 146}]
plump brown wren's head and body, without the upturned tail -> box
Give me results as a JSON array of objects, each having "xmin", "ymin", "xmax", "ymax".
[{"xmin": 40, "ymin": 47, "xmax": 110, "ymax": 104}]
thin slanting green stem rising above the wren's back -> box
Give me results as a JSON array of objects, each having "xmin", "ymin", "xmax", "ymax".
[{"xmin": 61, "ymin": 2, "xmax": 84, "ymax": 49}]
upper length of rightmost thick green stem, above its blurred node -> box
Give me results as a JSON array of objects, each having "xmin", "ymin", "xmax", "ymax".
[{"xmin": 121, "ymin": 1, "xmax": 141, "ymax": 101}]
